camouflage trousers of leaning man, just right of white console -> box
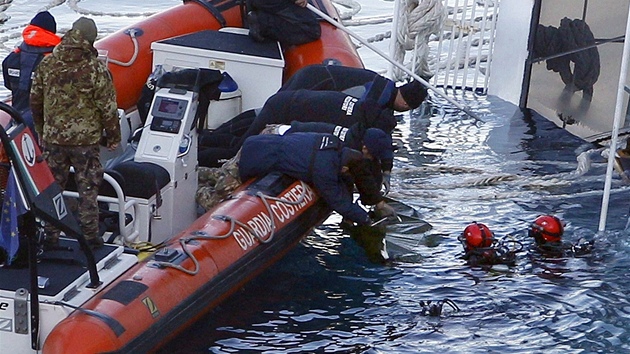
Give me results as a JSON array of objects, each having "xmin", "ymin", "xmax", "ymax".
[{"xmin": 195, "ymin": 150, "xmax": 241, "ymax": 210}]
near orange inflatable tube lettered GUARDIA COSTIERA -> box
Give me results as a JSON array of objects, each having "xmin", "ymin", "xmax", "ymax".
[{"xmin": 43, "ymin": 175, "xmax": 329, "ymax": 353}]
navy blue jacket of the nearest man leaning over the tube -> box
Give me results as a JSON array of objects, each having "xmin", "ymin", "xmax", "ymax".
[{"xmin": 239, "ymin": 133, "xmax": 370, "ymax": 225}]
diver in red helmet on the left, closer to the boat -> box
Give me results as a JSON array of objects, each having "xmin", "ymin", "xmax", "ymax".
[{"xmin": 458, "ymin": 221, "xmax": 523, "ymax": 266}]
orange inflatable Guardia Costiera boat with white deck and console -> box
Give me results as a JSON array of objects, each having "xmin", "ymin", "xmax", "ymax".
[{"xmin": 0, "ymin": 0, "xmax": 362, "ymax": 354}]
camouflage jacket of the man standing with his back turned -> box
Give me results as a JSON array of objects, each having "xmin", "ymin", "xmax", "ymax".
[{"xmin": 31, "ymin": 30, "xmax": 120, "ymax": 145}]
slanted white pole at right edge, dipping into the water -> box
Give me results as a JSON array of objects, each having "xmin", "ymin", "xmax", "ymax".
[{"xmin": 599, "ymin": 2, "xmax": 630, "ymax": 232}]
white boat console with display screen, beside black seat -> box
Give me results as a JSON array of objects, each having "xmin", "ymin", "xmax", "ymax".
[{"xmin": 134, "ymin": 88, "xmax": 198, "ymax": 242}]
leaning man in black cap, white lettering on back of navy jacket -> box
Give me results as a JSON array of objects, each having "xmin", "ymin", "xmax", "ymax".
[{"xmin": 198, "ymin": 75, "xmax": 427, "ymax": 175}]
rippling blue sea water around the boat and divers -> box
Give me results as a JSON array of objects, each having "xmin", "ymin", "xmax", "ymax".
[{"xmin": 0, "ymin": 0, "xmax": 630, "ymax": 353}]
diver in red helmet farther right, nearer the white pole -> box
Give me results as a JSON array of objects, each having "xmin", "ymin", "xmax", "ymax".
[{"xmin": 529, "ymin": 215, "xmax": 594, "ymax": 256}]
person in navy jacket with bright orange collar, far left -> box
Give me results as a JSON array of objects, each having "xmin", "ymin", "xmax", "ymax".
[{"xmin": 2, "ymin": 11, "xmax": 61, "ymax": 137}]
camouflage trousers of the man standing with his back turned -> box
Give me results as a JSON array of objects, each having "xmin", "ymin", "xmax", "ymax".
[{"xmin": 45, "ymin": 144, "xmax": 103, "ymax": 242}]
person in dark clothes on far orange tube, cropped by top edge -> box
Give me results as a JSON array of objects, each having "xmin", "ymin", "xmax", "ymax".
[{"xmin": 247, "ymin": 0, "xmax": 321, "ymax": 48}]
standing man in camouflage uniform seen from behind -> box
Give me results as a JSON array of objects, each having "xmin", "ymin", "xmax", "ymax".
[{"xmin": 30, "ymin": 17, "xmax": 121, "ymax": 248}]
